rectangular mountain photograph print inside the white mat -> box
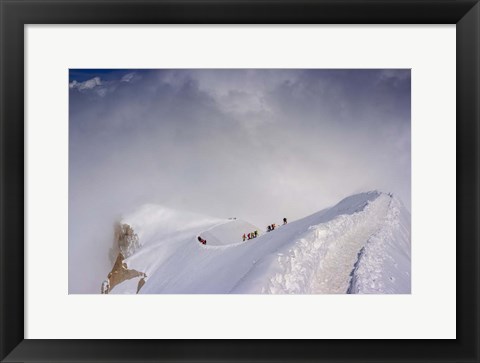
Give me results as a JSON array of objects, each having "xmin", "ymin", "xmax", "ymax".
[{"xmin": 68, "ymin": 69, "xmax": 411, "ymax": 294}]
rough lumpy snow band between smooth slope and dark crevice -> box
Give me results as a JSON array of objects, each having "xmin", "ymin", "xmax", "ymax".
[{"xmin": 260, "ymin": 194, "xmax": 390, "ymax": 293}]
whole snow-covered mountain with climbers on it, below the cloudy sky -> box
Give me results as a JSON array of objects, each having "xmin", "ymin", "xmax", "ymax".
[{"xmin": 107, "ymin": 191, "xmax": 411, "ymax": 294}]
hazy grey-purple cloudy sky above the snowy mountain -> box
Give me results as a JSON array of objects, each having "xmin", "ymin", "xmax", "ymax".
[{"xmin": 69, "ymin": 69, "xmax": 411, "ymax": 293}]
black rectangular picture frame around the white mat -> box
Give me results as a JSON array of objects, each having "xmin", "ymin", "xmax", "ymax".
[{"xmin": 0, "ymin": 0, "xmax": 480, "ymax": 362}]
